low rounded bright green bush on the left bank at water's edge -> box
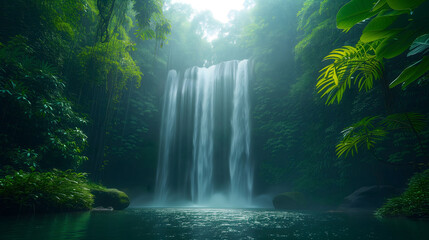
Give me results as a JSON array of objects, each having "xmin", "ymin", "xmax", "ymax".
[{"xmin": 0, "ymin": 169, "xmax": 93, "ymax": 213}]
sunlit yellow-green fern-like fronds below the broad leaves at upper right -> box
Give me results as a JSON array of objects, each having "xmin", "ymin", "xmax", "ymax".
[{"xmin": 316, "ymin": 43, "xmax": 383, "ymax": 105}]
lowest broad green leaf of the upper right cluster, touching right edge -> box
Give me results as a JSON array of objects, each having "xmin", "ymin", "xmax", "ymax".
[{"xmin": 389, "ymin": 56, "xmax": 429, "ymax": 88}]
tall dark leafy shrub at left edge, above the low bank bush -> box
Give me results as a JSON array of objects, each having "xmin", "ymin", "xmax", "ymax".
[{"xmin": 0, "ymin": 36, "xmax": 87, "ymax": 168}]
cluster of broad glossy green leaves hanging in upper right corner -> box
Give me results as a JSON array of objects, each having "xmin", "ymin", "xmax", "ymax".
[{"xmin": 337, "ymin": 0, "xmax": 429, "ymax": 88}]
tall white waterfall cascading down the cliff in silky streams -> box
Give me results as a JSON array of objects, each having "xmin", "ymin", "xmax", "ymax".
[{"xmin": 155, "ymin": 60, "xmax": 253, "ymax": 206}]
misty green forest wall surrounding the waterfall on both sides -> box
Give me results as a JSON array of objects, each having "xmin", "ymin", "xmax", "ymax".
[{"xmin": 0, "ymin": 0, "xmax": 429, "ymax": 206}]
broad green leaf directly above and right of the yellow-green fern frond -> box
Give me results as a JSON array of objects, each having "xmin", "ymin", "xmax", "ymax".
[{"xmin": 376, "ymin": 28, "xmax": 419, "ymax": 59}]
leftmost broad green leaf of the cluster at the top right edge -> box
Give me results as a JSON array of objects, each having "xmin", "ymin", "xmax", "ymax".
[{"xmin": 337, "ymin": 0, "xmax": 383, "ymax": 30}]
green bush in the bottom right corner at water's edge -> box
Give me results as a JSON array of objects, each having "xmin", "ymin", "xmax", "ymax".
[{"xmin": 375, "ymin": 169, "xmax": 429, "ymax": 218}]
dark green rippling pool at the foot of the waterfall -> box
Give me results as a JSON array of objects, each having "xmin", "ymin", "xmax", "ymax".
[{"xmin": 0, "ymin": 208, "xmax": 429, "ymax": 240}]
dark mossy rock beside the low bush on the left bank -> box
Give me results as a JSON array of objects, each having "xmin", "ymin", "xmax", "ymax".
[{"xmin": 91, "ymin": 188, "xmax": 130, "ymax": 210}]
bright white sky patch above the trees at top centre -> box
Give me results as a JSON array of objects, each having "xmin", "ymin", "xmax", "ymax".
[{"xmin": 172, "ymin": 0, "xmax": 244, "ymax": 23}]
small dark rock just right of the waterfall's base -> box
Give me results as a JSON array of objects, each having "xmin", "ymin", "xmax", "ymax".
[{"xmin": 273, "ymin": 192, "xmax": 307, "ymax": 210}]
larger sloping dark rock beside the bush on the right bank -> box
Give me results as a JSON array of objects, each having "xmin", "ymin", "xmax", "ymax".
[{"xmin": 339, "ymin": 185, "xmax": 398, "ymax": 210}]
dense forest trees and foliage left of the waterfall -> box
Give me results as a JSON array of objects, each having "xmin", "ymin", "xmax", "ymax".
[{"xmin": 0, "ymin": 0, "xmax": 170, "ymax": 192}]
